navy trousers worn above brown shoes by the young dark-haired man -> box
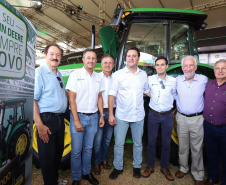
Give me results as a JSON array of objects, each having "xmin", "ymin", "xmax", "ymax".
[{"xmin": 147, "ymin": 111, "xmax": 174, "ymax": 169}]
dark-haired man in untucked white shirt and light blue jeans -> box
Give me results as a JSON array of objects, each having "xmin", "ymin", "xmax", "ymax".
[{"xmin": 108, "ymin": 47, "xmax": 149, "ymax": 179}]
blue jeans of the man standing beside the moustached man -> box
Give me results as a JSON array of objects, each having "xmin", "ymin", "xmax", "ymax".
[{"xmin": 70, "ymin": 113, "xmax": 98, "ymax": 180}]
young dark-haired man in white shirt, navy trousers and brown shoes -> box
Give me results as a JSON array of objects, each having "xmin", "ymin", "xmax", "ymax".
[{"xmin": 142, "ymin": 56, "xmax": 176, "ymax": 181}]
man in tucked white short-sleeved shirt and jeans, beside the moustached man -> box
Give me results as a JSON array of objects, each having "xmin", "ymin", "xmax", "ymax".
[{"xmin": 66, "ymin": 49, "xmax": 104, "ymax": 185}]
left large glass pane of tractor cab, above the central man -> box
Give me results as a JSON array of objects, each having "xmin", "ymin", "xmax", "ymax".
[{"xmin": 124, "ymin": 22, "xmax": 166, "ymax": 76}]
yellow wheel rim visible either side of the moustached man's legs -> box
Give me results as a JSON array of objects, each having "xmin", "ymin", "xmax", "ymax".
[{"xmin": 32, "ymin": 119, "xmax": 71, "ymax": 157}]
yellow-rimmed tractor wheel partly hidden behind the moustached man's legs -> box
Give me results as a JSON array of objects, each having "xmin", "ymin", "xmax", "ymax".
[{"xmin": 32, "ymin": 119, "xmax": 71, "ymax": 168}]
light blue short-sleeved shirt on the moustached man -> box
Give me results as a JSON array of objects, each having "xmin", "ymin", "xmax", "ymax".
[{"xmin": 34, "ymin": 64, "xmax": 67, "ymax": 113}]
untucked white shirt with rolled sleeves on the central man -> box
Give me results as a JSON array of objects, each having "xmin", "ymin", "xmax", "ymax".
[{"xmin": 109, "ymin": 67, "xmax": 149, "ymax": 122}]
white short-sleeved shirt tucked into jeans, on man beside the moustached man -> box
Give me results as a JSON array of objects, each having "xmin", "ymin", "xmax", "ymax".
[{"xmin": 66, "ymin": 67, "xmax": 104, "ymax": 113}]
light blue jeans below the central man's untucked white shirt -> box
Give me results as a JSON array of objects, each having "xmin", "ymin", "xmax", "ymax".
[{"xmin": 113, "ymin": 117, "xmax": 144, "ymax": 170}]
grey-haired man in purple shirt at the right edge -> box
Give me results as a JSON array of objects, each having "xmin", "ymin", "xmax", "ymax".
[{"xmin": 203, "ymin": 59, "xmax": 226, "ymax": 185}]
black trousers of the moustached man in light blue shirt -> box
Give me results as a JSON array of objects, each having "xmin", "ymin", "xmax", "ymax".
[{"xmin": 37, "ymin": 113, "xmax": 64, "ymax": 185}]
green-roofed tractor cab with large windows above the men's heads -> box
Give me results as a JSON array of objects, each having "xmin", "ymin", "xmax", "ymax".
[{"xmin": 99, "ymin": 5, "xmax": 214, "ymax": 79}]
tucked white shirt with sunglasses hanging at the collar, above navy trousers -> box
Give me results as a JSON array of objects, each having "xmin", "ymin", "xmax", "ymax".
[{"xmin": 148, "ymin": 74, "xmax": 176, "ymax": 112}]
